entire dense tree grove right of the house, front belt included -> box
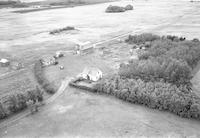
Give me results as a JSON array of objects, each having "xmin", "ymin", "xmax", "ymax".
[{"xmin": 95, "ymin": 33, "xmax": 200, "ymax": 119}]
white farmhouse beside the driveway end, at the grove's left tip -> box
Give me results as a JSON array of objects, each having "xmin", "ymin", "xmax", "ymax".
[{"xmin": 78, "ymin": 67, "xmax": 103, "ymax": 81}]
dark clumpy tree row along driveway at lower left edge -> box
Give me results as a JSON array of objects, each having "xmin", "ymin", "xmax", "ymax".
[{"xmin": 0, "ymin": 87, "xmax": 43, "ymax": 119}]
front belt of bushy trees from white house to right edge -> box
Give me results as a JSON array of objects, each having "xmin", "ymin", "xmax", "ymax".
[{"xmin": 95, "ymin": 76, "xmax": 200, "ymax": 119}]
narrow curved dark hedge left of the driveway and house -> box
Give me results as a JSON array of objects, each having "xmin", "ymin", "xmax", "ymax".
[{"xmin": 34, "ymin": 60, "xmax": 57, "ymax": 94}]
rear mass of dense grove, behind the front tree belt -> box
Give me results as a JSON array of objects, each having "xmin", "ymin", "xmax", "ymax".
[{"xmin": 119, "ymin": 33, "xmax": 200, "ymax": 87}]
